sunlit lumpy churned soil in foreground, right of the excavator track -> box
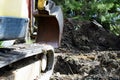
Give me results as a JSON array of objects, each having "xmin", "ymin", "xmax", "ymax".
[{"xmin": 51, "ymin": 51, "xmax": 120, "ymax": 80}]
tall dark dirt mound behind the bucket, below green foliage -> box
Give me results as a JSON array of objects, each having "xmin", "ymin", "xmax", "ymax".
[{"xmin": 61, "ymin": 19, "xmax": 120, "ymax": 51}]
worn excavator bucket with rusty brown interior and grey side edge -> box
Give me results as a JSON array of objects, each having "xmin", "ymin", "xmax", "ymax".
[{"xmin": 33, "ymin": 0, "xmax": 63, "ymax": 48}]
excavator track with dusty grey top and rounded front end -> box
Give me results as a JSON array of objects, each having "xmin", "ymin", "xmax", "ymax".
[{"xmin": 0, "ymin": 43, "xmax": 54, "ymax": 80}]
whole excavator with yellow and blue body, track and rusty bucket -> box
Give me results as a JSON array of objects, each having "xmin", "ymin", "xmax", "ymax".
[{"xmin": 0, "ymin": 0, "xmax": 63, "ymax": 80}]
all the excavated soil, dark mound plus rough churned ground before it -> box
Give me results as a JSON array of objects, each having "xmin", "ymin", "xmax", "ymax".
[{"xmin": 50, "ymin": 19, "xmax": 120, "ymax": 80}]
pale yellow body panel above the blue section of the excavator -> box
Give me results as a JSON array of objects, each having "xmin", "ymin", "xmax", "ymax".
[{"xmin": 0, "ymin": 0, "xmax": 28, "ymax": 18}]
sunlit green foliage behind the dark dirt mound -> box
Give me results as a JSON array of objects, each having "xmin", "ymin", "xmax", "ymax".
[{"xmin": 54, "ymin": 0, "xmax": 120, "ymax": 36}]
